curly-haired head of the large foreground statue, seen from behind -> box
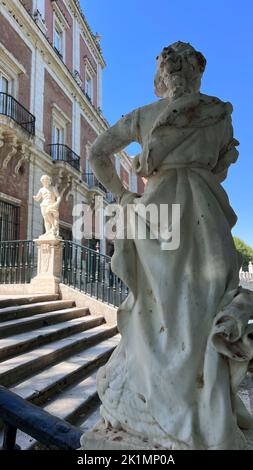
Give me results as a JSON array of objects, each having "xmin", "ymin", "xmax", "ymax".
[{"xmin": 154, "ymin": 41, "xmax": 206, "ymax": 98}]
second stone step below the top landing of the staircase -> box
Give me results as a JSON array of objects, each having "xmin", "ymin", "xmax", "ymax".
[{"xmin": 0, "ymin": 307, "xmax": 90, "ymax": 343}]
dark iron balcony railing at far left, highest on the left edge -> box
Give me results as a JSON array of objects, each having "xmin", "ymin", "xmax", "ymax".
[{"xmin": 0, "ymin": 92, "xmax": 35, "ymax": 135}]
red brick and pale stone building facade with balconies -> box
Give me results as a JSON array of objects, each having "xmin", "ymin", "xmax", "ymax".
[{"xmin": 0, "ymin": 0, "xmax": 144, "ymax": 253}]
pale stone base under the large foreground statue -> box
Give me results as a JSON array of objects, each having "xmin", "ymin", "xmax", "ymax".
[{"xmin": 80, "ymin": 421, "xmax": 165, "ymax": 450}]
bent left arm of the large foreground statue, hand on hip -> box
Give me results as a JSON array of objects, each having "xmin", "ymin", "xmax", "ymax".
[{"xmin": 89, "ymin": 112, "xmax": 137, "ymax": 197}]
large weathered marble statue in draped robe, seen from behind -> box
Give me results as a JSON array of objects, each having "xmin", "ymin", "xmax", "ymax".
[{"xmin": 85, "ymin": 42, "xmax": 253, "ymax": 449}]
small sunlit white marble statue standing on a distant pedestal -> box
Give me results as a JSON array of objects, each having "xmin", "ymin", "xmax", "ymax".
[{"xmin": 33, "ymin": 175, "xmax": 61, "ymax": 239}]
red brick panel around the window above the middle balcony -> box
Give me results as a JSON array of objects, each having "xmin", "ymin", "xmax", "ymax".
[{"xmin": 44, "ymin": 71, "xmax": 72, "ymax": 148}]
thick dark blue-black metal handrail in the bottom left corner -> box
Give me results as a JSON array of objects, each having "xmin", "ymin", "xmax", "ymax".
[{"xmin": 0, "ymin": 386, "xmax": 83, "ymax": 450}]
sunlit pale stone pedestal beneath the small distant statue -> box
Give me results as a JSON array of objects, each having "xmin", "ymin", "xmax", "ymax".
[{"xmin": 31, "ymin": 238, "xmax": 62, "ymax": 294}]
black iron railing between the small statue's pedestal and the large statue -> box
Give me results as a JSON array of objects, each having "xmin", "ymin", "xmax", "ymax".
[{"xmin": 62, "ymin": 240, "xmax": 128, "ymax": 306}]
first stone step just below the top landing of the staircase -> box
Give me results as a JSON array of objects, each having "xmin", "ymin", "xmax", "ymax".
[{"xmin": 0, "ymin": 300, "xmax": 75, "ymax": 323}]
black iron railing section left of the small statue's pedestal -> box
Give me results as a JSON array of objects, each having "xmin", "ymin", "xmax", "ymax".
[{"xmin": 0, "ymin": 240, "xmax": 37, "ymax": 284}]
